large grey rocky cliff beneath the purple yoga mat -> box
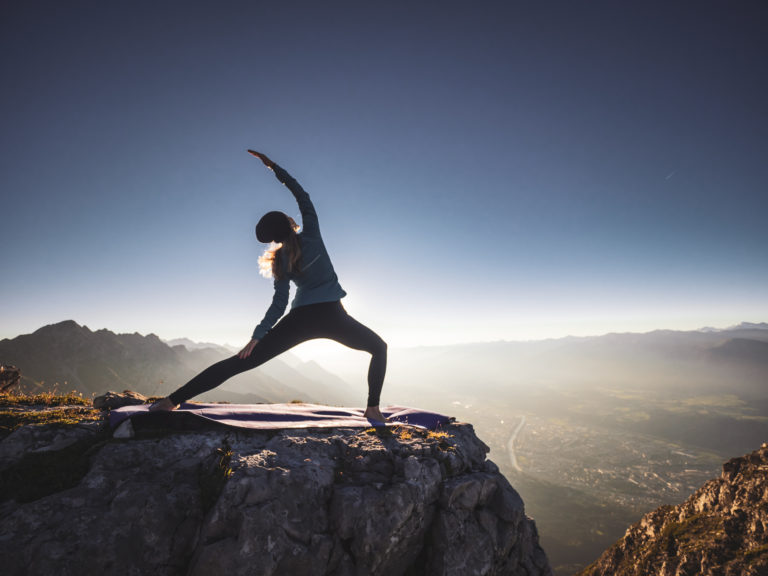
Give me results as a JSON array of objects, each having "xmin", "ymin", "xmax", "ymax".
[{"xmin": 0, "ymin": 396, "xmax": 551, "ymax": 576}]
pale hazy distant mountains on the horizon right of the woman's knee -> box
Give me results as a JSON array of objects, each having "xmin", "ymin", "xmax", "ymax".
[{"xmin": 388, "ymin": 323, "xmax": 768, "ymax": 400}]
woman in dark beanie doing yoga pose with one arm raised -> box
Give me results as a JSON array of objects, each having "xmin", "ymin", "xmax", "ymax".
[{"xmin": 149, "ymin": 150, "xmax": 387, "ymax": 422}]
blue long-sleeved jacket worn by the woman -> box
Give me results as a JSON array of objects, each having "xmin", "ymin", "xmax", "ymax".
[{"xmin": 253, "ymin": 164, "xmax": 347, "ymax": 340}]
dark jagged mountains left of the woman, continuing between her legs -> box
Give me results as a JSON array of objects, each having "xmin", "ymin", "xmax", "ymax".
[{"xmin": 0, "ymin": 320, "xmax": 362, "ymax": 404}]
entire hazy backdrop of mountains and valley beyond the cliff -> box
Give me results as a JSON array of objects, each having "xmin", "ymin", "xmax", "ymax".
[{"xmin": 0, "ymin": 322, "xmax": 768, "ymax": 574}]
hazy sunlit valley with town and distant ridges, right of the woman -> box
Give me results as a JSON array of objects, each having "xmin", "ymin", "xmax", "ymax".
[{"xmin": 388, "ymin": 324, "xmax": 768, "ymax": 575}]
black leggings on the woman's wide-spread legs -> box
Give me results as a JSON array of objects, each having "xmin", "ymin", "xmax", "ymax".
[{"xmin": 169, "ymin": 301, "xmax": 387, "ymax": 406}]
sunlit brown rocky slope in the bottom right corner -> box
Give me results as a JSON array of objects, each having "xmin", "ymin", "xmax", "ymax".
[{"xmin": 581, "ymin": 444, "xmax": 768, "ymax": 576}]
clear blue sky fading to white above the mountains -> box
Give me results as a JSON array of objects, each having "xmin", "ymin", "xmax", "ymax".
[{"xmin": 0, "ymin": 0, "xmax": 768, "ymax": 345}]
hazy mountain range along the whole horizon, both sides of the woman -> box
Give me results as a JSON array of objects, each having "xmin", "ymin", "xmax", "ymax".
[{"xmin": 0, "ymin": 320, "xmax": 768, "ymax": 410}]
